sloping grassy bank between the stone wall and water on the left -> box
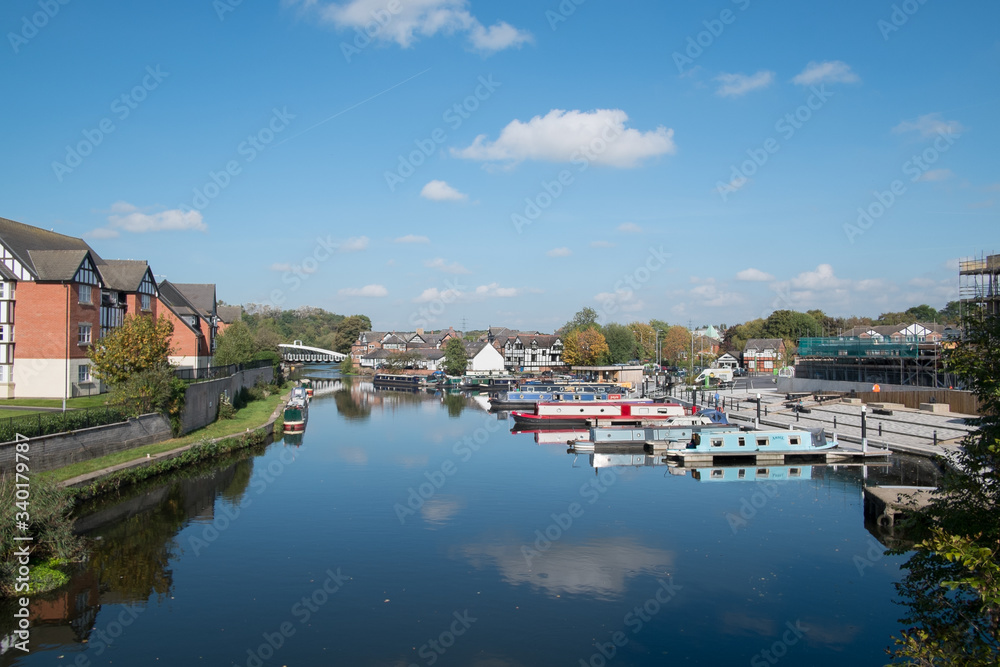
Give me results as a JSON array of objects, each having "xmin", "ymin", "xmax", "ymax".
[{"xmin": 47, "ymin": 392, "xmax": 290, "ymax": 498}]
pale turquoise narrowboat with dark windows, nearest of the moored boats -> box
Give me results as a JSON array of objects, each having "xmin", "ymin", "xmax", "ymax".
[{"xmin": 665, "ymin": 429, "xmax": 837, "ymax": 457}]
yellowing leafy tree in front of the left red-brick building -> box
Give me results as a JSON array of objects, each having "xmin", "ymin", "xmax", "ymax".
[{"xmin": 87, "ymin": 315, "xmax": 174, "ymax": 386}]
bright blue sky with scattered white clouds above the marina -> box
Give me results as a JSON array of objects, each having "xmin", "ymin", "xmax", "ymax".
[{"xmin": 0, "ymin": 0, "xmax": 1000, "ymax": 331}]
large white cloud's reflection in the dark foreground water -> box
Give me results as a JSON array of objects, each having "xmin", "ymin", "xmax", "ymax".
[{"xmin": 462, "ymin": 539, "xmax": 674, "ymax": 600}]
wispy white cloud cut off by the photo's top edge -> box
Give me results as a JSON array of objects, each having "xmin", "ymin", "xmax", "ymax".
[{"xmin": 287, "ymin": 0, "xmax": 532, "ymax": 53}]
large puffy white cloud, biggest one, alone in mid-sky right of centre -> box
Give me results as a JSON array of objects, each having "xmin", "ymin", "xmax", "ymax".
[{"xmin": 451, "ymin": 109, "xmax": 677, "ymax": 168}]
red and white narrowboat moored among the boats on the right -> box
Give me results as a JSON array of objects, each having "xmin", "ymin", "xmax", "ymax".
[{"xmin": 510, "ymin": 401, "xmax": 685, "ymax": 428}]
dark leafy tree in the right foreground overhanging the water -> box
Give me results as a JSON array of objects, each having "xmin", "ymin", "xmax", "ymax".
[{"xmin": 895, "ymin": 317, "xmax": 1000, "ymax": 666}]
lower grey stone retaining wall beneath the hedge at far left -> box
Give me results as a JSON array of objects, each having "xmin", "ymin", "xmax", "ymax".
[{"xmin": 0, "ymin": 414, "xmax": 172, "ymax": 473}]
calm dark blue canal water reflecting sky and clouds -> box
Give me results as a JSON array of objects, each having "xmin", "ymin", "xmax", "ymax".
[{"xmin": 4, "ymin": 374, "xmax": 927, "ymax": 667}]
